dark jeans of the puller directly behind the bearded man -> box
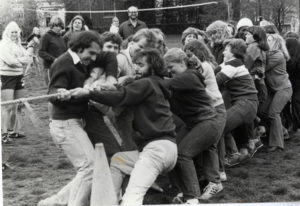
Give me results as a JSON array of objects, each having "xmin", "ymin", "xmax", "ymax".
[{"xmin": 170, "ymin": 117, "xmax": 222, "ymax": 199}]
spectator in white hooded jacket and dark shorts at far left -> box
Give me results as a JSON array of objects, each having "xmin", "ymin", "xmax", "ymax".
[{"xmin": 0, "ymin": 21, "xmax": 29, "ymax": 143}]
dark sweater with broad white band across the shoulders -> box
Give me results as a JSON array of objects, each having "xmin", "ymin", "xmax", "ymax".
[{"xmin": 216, "ymin": 59, "xmax": 257, "ymax": 103}]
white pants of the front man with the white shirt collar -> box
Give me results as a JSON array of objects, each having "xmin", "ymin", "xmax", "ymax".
[{"xmin": 50, "ymin": 119, "xmax": 95, "ymax": 206}]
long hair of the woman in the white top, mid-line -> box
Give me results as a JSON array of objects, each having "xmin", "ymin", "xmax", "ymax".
[{"xmin": 183, "ymin": 40, "xmax": 218, "ymax": 66}]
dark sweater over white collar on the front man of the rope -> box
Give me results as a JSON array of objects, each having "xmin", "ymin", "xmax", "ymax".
[{"xmin": 48, "ymin": 52, "xmax": 89, "ymax": 120}]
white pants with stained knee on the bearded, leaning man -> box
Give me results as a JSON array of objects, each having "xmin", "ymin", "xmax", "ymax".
[{"xmin": 110, "ymin": 140, "xmax": 177, "ymax": 205}]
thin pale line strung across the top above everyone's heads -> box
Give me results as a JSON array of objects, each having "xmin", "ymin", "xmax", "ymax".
[{"xmin": 27, "ymin": 1, "xmax": 218, "ymax": 14}]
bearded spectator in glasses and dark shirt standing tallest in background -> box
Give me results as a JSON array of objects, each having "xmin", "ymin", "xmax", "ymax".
[{"xmin": 119, "ymin": 6, "xmax": 147, "ymax": 39}]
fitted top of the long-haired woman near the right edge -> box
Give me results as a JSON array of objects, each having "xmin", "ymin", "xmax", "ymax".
[{"xmin": 266, "ymin": 50, "xmax": 291, "ymax": 91}]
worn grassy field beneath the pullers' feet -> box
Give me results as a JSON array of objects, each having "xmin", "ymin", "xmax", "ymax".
[{"xmin": 3, "ymin": 38, "xmax": 300, "ymax": 206}]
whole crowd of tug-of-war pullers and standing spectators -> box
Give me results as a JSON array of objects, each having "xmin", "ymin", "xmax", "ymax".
[{"xmin": 0, "ymin": 4, "xmax": 300, "ymax": 206}]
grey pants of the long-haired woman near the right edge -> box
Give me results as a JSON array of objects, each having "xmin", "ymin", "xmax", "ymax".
[{"xmin": 262, "ymin": 87, "xmax": 293, "ymax": 149}]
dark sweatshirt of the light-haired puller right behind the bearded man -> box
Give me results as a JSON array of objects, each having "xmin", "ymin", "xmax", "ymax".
[{"xmin": 166, "ymin": 69, "xmax": 216, "ymax": 127}]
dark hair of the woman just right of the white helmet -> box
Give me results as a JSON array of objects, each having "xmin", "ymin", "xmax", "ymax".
[{"xmin": 248, "ymin": 26, "xmax": 270, "ymax": 51}]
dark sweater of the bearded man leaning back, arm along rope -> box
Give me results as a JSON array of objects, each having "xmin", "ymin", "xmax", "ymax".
[{"xmin": 90, "ymin": 76, "xmax": 175, "ymax": 149}]
